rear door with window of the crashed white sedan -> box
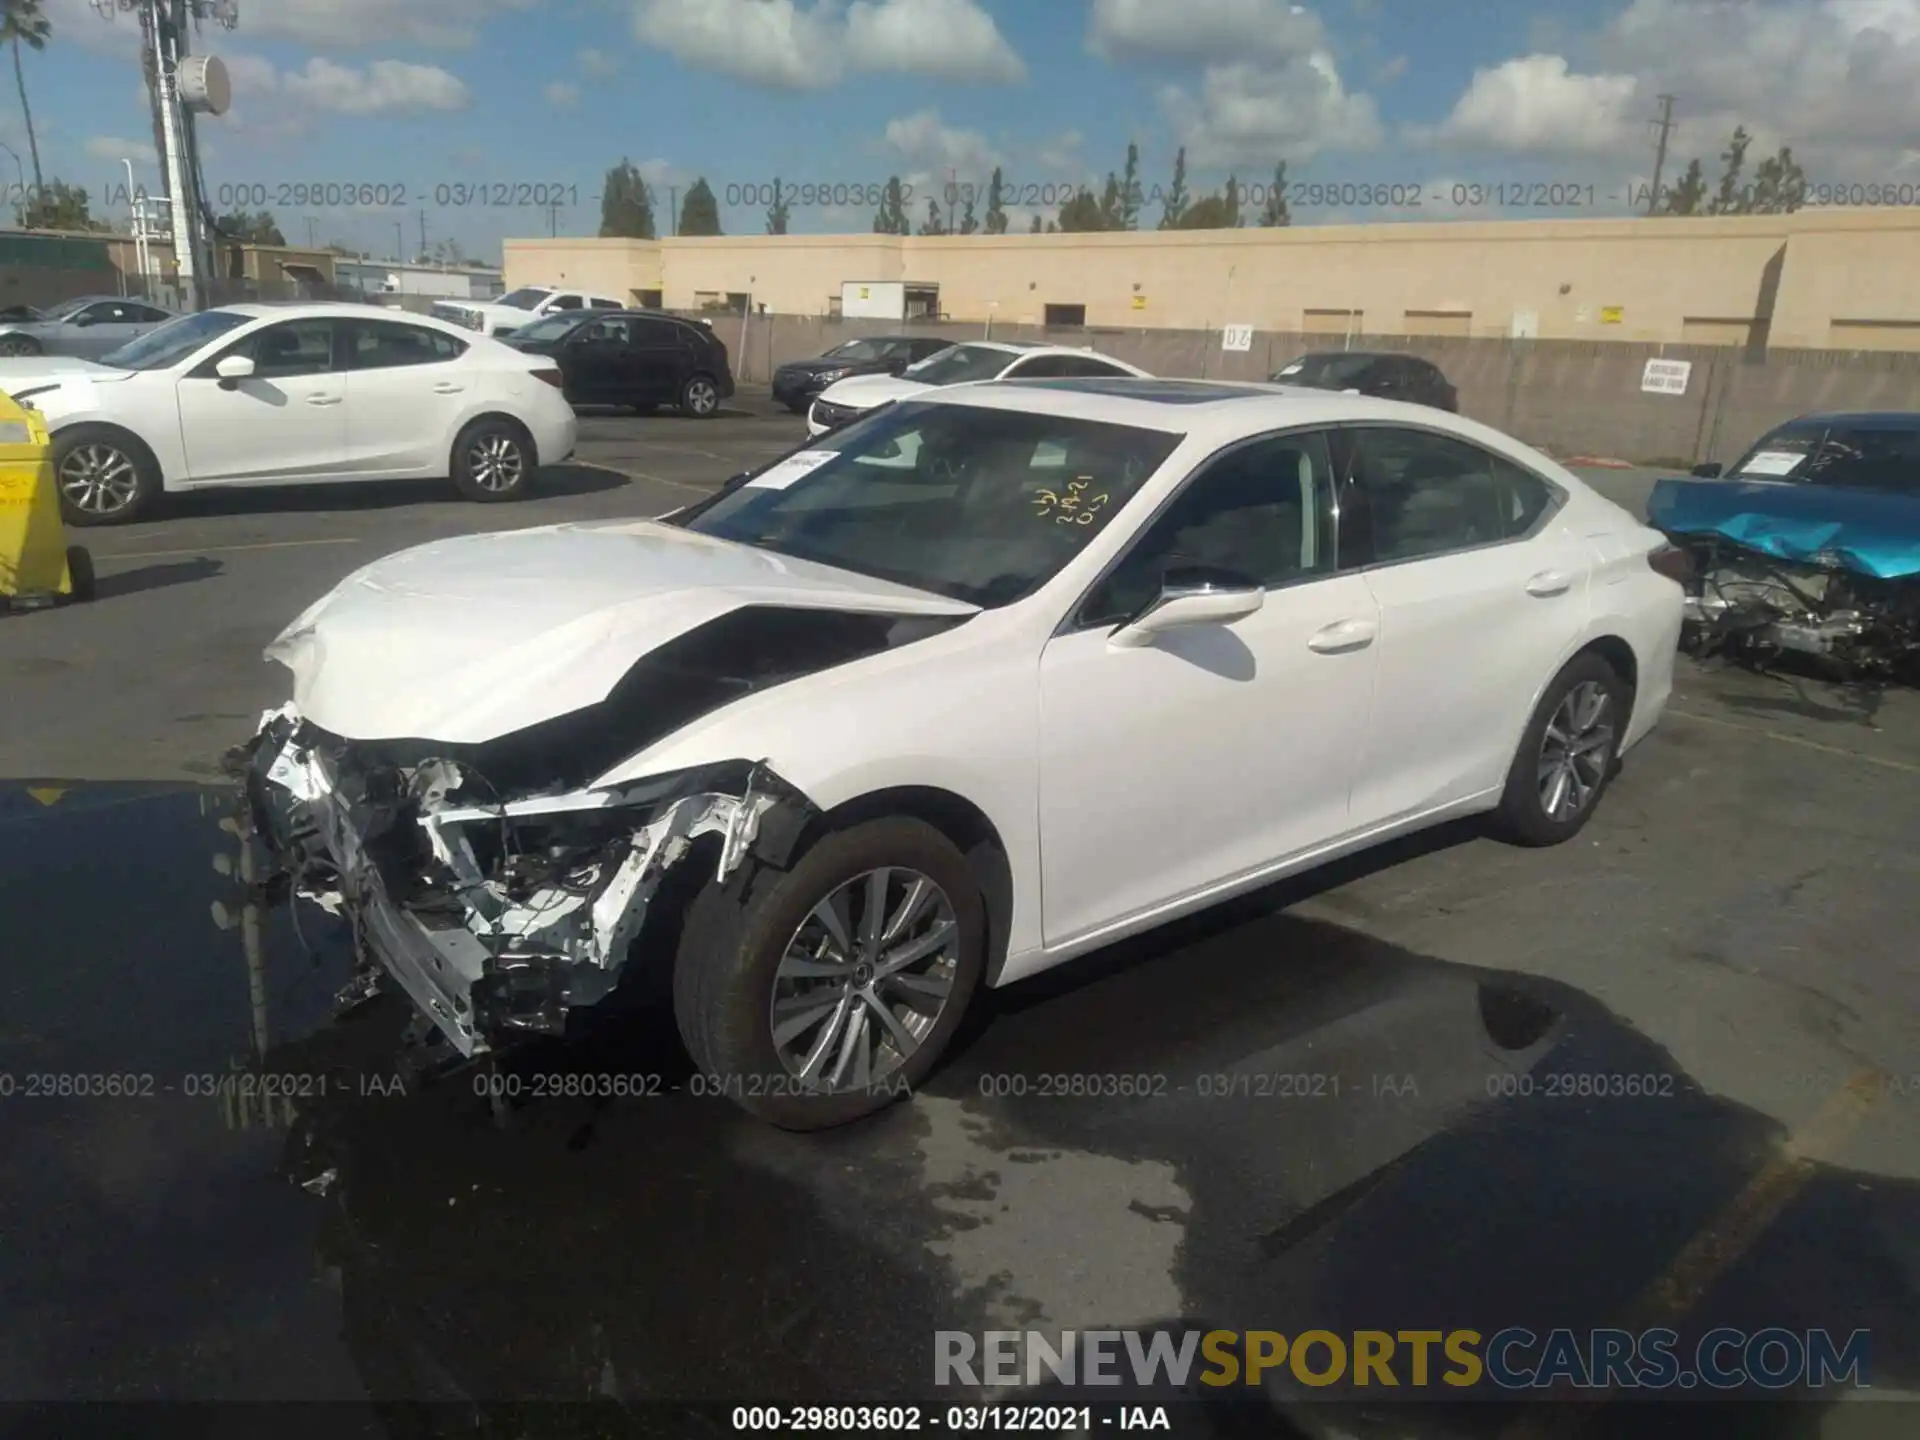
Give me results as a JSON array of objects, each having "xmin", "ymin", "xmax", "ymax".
[{"xmin": 1340, "ymin": 426, "xmax": 1592, "ymax": 828}]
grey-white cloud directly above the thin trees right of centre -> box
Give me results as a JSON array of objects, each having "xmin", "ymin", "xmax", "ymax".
[{"xmin": 1160, "ymin": 50, "xmax": 1380, "ymax": 169}]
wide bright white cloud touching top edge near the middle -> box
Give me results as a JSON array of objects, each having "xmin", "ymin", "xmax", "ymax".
[{"xmin": 634, "ymin": 0, "xmax": 1025, "ymax": 90}]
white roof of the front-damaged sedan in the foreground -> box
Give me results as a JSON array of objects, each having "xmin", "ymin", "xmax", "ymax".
[{"xmin": 912, "ymin": 376, "xmax": 1519, "ymax": 445}]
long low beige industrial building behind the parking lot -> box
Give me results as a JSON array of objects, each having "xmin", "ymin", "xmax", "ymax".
[{"xmin": 505, "ymin": 207, "xmax": 1920, "ymax": 353}]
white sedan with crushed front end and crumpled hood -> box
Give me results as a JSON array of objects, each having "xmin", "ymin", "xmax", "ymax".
[{"xmin": 234, "ymin": 378, "xmax": 1684, "ymax": 1129}]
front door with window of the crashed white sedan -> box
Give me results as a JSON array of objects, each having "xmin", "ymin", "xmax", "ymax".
[{"xmin": 1041, "ymin": 432, "xmax": 1379, "ymax": 945}]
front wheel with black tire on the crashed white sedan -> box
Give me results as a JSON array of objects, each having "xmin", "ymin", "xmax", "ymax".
[{"xmin": 674, "ymin": 816, "xmax": 987, "ymax": 1131}]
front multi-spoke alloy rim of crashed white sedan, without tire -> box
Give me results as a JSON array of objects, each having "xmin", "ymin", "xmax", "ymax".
[{"xmin": 770, "ymin": 868, "xmax": 960, "ymax": 1092}]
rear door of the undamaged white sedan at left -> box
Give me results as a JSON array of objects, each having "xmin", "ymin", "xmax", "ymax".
[{"xmin": 344, "ymin": 321, "xmax": 476, "ymax": 480}]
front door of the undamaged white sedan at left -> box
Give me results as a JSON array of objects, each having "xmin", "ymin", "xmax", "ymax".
[{"xmin": 175, "ymin": 319, "xmax": 346, "ymax": 486}]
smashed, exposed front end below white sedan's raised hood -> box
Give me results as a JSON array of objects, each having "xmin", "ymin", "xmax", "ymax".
[{"xmin": 230, "ymin": 607, "xmax": 958, "ymax": 1056}]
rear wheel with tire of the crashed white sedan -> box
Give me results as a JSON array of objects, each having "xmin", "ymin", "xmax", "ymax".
[{"xmin": 1496, "ymin": 651, "xmax": 1632, "ymax": 847}]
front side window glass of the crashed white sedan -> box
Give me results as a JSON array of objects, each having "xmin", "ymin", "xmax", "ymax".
[{"xmin": 1077, "ymin": 430, "xmax": 1334, "ymax": 628}]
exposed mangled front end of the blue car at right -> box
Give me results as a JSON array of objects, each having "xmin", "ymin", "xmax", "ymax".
[{"xmin": 1670, "ymin": 534, "xmax": 1920, "ymax": 684}]
